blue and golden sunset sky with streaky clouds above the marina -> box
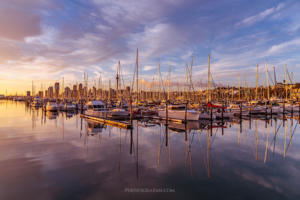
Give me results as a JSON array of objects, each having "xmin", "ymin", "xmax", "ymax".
[{"xmin": 0, "ymin": 0, "xmax": 300, "ymax": 94}]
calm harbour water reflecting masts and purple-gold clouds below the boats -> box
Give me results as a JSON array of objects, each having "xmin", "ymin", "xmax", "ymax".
[{"xmin": 0, "ymin": 101, "xmax": 300, "ymax": 200}]
